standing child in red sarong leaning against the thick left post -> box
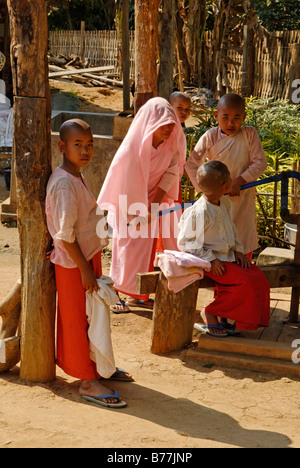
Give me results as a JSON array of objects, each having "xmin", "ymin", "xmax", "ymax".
[{"xmin": 46, "ymin": 119, "xmax": 131, "ymax": 407}]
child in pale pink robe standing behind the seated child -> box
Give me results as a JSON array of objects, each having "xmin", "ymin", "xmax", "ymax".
[{"xmin": 185, "ymin": 93, "xmax": 267, "ymax": 255}]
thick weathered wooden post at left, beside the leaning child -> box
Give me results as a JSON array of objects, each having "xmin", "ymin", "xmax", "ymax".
[{"xmin": 7, "ymin": 0, "xmax": 55, "ymax": 382}]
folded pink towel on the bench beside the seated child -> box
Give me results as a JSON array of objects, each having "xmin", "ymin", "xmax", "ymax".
[{"xmin": 155, "ymin": 250, "xmax": 211, "ymax": 293}]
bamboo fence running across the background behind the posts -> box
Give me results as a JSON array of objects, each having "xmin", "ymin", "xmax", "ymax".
[{"xmin": 49, "ymin": 31, "xmax": 300, "ymax": 99}]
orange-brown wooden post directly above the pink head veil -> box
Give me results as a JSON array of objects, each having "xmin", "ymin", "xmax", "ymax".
[{"xmin": 135, "ymin": 0, "xmax": 159, "ymax": 112}]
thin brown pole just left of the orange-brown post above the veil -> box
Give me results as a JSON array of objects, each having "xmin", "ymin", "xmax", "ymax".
[{"xmin": 122, "ymin": 0, "xmax": 130, "ymax": 111}]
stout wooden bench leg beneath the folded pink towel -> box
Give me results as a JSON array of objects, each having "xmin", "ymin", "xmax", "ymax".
[{"xmin": 151, "ymin": 273, "xmax": 199, "ymax": 354}]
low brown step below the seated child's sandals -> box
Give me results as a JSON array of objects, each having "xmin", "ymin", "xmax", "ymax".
[{"xmin": 186, "ymin": 335, "xmax": 300, "ymax": 378}]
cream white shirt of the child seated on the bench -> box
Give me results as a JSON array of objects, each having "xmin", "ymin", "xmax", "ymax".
[{"xmin": 177, "ymin": 196, "xmax": 244, "ymax": 262}]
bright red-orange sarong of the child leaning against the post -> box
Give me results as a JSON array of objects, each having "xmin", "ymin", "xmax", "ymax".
[{"xmin": 55, "ymin": 251, "xmax": 102, "ymax": 380}]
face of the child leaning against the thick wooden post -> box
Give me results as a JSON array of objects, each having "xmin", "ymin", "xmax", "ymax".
[{"xmin": 58, "ymin": 129, "xmax": 94, "ymax": 171}]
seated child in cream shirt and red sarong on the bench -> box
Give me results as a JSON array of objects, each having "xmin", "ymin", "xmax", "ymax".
[{"xmin": 178, "ymin": 161, "xmax": 270, "ymax": 337}]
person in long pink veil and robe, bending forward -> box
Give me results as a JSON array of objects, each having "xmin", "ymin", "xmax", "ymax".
[{"xmin": 98, "ymin": 98, "xmax": 186, "ymax": 311}]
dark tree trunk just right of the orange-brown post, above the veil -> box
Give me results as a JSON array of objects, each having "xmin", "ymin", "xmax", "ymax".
[{"xmin": 158, "ymin": 0, "xmax": 175, "ymax": 99}]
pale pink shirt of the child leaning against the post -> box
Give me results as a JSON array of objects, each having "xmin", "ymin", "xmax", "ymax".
[{"xmin": 46, "ymin": 167, "xmax": 108, "ymax": 268}]
